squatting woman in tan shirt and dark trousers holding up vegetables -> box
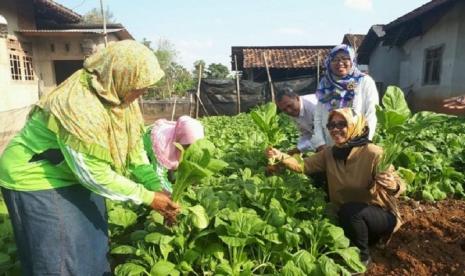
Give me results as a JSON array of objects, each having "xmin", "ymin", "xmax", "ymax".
[{"xmin": 265, "ymin": 108, "xmax": 405, "ymax": 264}]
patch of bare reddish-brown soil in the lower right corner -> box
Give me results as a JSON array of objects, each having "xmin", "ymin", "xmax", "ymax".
[{"xmin": 366, "ymin": 200, "xmax": 465, "ymax": 276}]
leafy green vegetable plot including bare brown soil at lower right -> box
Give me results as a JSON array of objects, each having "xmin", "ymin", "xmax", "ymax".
[{"xmin": 0, "ymin": 87, "xmax": 465, "ymax": 275}]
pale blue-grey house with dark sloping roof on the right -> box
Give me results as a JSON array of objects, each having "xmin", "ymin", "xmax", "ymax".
[{"xmin": 358, "ymin": 0, "xmax": 465, "ymax": 112}]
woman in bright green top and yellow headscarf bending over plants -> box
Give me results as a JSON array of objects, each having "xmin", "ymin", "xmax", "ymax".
[{"xmin": 0, "ymin": 40, "xmax": 179, "ymax": 275}]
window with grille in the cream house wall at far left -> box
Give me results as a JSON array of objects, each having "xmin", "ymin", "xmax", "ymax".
[{"xmin": 8, "ymin": 37, "xmax": 34, "ymax": 81}]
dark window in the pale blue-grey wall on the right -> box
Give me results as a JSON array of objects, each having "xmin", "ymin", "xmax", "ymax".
[{"xmin": 423, "ymin": 46, "xmax": 444, "ymax": 85}]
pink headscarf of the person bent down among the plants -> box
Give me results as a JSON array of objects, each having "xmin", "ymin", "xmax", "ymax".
[{"xmin": 151, "ymin": 116, "xmax": 205, "ymax": 170}]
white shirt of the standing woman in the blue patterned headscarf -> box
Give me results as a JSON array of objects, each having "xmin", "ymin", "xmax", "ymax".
[{"xmin": 312, "ymin": 75, "xmax": 379, "ymax": 147}]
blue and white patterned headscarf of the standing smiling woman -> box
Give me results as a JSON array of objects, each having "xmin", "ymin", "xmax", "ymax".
[{"xmin": 316, "ymin": 44, "xmax": 365, "ymax": 110}]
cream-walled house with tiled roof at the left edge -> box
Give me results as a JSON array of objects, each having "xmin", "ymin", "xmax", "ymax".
[{"xmin": 0, "ymin": 0, "xmax": 133, "ymax": 152}]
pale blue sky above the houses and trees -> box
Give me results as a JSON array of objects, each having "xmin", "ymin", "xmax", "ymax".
[{"xmin": 55, "ymin": 0, "xmax": 428, "ymax": 69}]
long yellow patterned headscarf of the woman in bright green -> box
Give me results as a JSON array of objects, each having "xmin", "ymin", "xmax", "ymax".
[{"xmin": 38, "ymin": 40, "xmax": 164, "ymax": 174}]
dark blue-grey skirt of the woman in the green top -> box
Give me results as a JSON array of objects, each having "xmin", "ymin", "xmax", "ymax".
[{"xmin": 2, "ymin": 185, "xmax": 110, "ymax": 275}]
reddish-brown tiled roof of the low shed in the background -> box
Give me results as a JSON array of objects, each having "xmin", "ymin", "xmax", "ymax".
[{"xmin": 232, "ymin": 46, "xmax": 334, "ymax": 70}]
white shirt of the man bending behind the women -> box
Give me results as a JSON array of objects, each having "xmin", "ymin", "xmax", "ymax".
[{"xmin": 292, "ymin": 94, "xmax": 318, "ymax": 152}]
